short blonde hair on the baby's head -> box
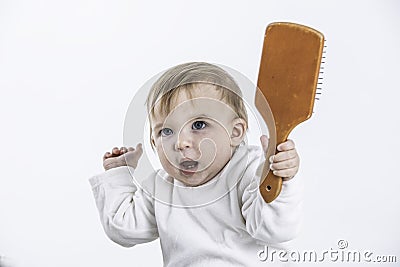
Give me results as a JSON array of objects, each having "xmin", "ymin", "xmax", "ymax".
[{"xmin": 146, "ymin": 62, "xmax": 248, "ymax": 130}]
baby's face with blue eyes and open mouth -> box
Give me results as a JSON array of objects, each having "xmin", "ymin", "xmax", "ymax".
[{"xmin": 151, "ymin": 84, "xmax": 245, "ymax": 186}]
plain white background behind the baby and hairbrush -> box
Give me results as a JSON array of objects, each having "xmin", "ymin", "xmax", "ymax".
[{"xmin": 0, "ymin": 0, "xmax": 400, "ymax": 267}]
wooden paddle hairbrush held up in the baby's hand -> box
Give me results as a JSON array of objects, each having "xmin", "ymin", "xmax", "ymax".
[{"xmin": 255, "ymin": 22, "xmax": 324, "ymax": 203}]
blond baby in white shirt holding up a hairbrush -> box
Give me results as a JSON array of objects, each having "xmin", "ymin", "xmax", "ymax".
[{"xmin": 90, "ymin": 62, "xmax": 302, "ymax": 267}]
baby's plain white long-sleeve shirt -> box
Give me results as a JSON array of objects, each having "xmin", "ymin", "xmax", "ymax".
[{"xmin": 90, "ymin": 146, "xmax": 302, "ymax": 267}]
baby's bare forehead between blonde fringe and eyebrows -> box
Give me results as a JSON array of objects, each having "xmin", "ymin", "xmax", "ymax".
[{"xmin": 151, "ymin": 84, "xmax": 235, "ymax": 129}]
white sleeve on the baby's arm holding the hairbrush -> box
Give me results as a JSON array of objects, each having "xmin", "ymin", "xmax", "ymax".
[{"xmin": 242, "ymin": 174, "xmax": 303, "ymax": 247}]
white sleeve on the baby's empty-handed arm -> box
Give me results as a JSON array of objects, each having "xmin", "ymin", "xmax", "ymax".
[{"xmin": 89, "ymin": 166, "xmax": 158, "ymax": 247}]
